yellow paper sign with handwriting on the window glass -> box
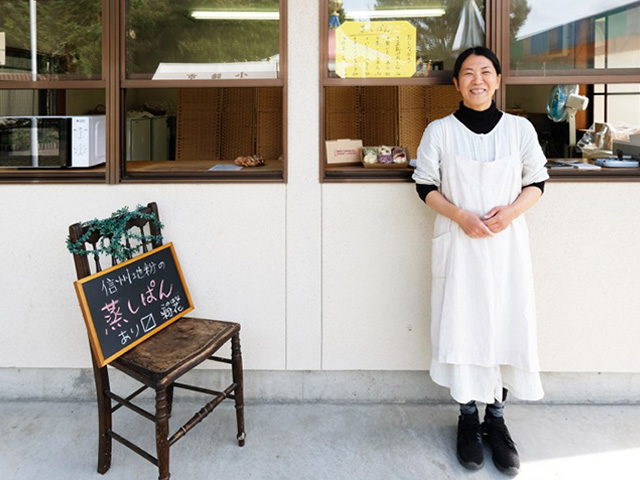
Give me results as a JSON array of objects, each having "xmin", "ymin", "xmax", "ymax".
[{"xmin": 336, "ymin": 20, "xmax": 416, "ymax": 78}]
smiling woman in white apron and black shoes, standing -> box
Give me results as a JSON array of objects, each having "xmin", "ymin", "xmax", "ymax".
[{"xmin": 413, "ymin": 47, "xmax": 548, "ymax": 475}]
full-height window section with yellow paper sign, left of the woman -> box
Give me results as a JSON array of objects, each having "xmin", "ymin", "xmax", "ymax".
[{"xmin": 320, "ymin": 0, "xmax": 487, "ymax": 181}]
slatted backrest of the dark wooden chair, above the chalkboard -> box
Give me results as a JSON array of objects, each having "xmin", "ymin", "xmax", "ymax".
[{"xmin": 69, "ymin": 202, "xmax": 162, "ymax": 280}]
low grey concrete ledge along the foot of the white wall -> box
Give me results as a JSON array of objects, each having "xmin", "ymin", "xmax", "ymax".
[{"xmin": 0, "ymin": 368, "xmax": 640, "ymax": 405}]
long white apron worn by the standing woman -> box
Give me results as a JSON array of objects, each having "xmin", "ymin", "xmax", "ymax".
[{"xmin": 430, "ymin": 116, "xmax": 542, "ymax": 403}]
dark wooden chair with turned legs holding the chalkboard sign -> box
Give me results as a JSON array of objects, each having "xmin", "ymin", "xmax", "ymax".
[{"xmin": 69, "ymin": 203, "xmax": 245, "ymax": 480}]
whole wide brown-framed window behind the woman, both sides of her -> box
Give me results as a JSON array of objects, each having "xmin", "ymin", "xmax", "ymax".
[{"xmin": 320, "ymin": 0, "xmax": 640, "ymax": 182}]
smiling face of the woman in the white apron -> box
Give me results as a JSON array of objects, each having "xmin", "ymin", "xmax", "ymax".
[{"xmin": 453, "ymin": 55, "xmax": 501, "ymax": 111}]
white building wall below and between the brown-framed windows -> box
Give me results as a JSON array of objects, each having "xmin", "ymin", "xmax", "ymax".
[{"xmin": 0, "ymin": 1, "xmax": 640, "ymax": 373}]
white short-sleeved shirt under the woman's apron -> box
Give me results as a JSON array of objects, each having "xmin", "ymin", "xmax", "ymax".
[{"xmin": 412, "ymin": 113, "xmax": 549, "ymax": 187}]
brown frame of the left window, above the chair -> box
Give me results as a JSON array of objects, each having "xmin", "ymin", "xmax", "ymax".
[{"xmin": 0, "ymin": 0, "xmax": 288, "ymax": 184}]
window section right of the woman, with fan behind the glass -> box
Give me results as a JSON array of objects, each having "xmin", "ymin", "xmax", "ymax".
[{"xmin": 503, "ymin": 0, "xmax": 640, "ymax": 180}]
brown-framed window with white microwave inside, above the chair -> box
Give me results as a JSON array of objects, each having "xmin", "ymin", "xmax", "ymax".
[{"xmin": 0, "ymin": 0, "xmax": 286, "ymax": 183}]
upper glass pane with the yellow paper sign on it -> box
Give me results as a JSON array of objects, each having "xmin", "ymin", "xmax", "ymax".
[{"xmin": 327, "ymin": 0, "xmax": 485, "ymax": 78}]
